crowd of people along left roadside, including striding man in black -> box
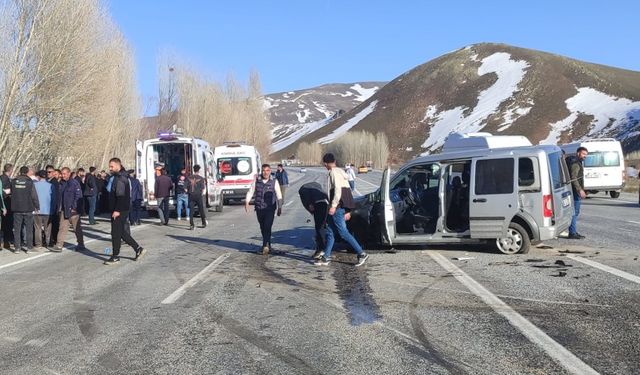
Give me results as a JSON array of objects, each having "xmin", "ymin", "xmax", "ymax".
[{"xmin": 0, "ymin": 158, "xmax": 144, "ymax": 264}]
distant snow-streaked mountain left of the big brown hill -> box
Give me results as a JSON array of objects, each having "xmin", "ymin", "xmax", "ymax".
[{"xmin": 264, "ymin": 82, "xmax": 385, "ymax": 152}]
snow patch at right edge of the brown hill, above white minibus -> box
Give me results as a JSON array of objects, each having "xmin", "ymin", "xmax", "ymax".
[{"xmin": 540, "ymin": 87, "xmax": 640, "ymax": 144}]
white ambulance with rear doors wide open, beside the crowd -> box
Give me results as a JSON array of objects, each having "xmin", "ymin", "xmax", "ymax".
[{"xmin": 136, "ymin": 131, "xmax": 223, "ymax": 212}]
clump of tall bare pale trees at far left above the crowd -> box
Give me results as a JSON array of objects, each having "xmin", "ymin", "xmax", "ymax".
[{"xmin": 0, "ymin": 0, "xmax": 139, "ymax": 169}]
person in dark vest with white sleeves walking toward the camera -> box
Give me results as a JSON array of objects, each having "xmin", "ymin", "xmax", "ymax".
[{"xmin": 244, "ymin": 164, "xmax": 282, "ymax": 255}]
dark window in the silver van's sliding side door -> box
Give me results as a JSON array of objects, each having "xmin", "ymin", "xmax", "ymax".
[{"xmin": 475, "ymin": 158, "xmax": 515, "ymax": 195}]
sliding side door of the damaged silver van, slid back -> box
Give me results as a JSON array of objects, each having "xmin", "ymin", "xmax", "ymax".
[{"xmin": 469, "ymin": 157, "xmax": 518, "ymax": 239}]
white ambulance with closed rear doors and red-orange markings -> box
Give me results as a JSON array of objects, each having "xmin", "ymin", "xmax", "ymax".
[{"xmin": 213, "ymin": 142, "xmax": 261, "ymax": 204}]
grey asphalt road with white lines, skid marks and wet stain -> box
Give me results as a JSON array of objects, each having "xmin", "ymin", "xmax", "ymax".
[{"xmin": 0, "ymin": 169, "xmax": 640, "ymax": 374}]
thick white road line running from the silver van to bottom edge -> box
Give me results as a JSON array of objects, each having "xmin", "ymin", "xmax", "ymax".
[{"xmin": 427, "ymin": 251, "xmax": 598, "ymax": 374}]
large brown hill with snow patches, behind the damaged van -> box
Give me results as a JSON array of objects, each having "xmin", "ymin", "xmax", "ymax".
[{"xmin": 276, "ymin": 44, "xmax": 640, "ymax": 162}]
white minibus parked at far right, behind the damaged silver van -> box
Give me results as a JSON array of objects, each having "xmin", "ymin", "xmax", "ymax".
[{"xmin": 560, "ymin": 138, "xmax": 626, "ymax": 198}]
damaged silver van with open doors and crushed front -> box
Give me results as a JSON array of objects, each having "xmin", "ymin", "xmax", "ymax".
[{"xmin": 349, "ymin": 133, "xmax": 573, "ymax": 254}]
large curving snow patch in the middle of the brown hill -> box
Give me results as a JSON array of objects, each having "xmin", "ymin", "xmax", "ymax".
[{"xmin": 422, "ymin": 52, "xmax": 529, "ymax": 154}]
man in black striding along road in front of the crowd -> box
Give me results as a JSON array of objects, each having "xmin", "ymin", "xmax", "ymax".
[{"xmin": 104, "ymin": 158, "xmax": 144, "ymax": 265}]
